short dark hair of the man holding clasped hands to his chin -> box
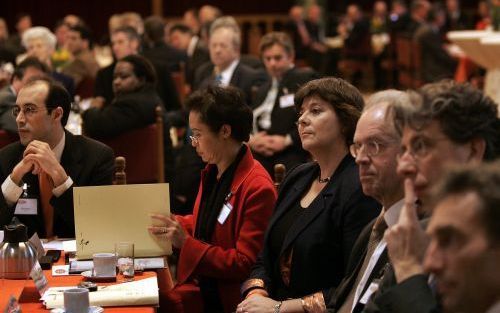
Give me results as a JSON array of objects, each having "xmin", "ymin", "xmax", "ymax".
[{"xmin": 23, "ymin": 76, "xmax": 71, "ymax": 127}]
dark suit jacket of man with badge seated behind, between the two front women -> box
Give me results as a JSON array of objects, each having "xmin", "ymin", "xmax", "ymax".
[{"xmin": 252, "ymin": 67, "xmax": 319, "ymax": 174}]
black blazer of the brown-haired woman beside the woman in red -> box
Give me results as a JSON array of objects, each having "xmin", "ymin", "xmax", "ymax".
[{"xmin": 250, "ymin": 155, "xmax": 380, "ymax": 302}]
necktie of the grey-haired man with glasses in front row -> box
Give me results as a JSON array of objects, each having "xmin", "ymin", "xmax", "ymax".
[{"xmin": 338, "ymin": 214, "xmax": 387, "ymax": 313}]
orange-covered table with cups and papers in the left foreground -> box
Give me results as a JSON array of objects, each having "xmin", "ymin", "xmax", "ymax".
[{"xmin": 0, "ymin": 255, "xmax": 172, "ymax": 313}]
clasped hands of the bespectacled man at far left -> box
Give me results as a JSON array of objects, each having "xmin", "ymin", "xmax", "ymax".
[{"xmin": 11, "ymin": 140, "xmax": 68, "ymax": 187}]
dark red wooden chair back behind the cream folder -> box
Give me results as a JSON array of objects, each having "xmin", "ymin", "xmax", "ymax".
[{"xmin": 102, "ymin": 106, "xmax": 165, "ymax": 184}]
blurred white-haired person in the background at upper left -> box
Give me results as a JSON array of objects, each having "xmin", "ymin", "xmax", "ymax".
[{"xmin": 22, "ymin": 26, "xmax": 75, "ymax": 96}]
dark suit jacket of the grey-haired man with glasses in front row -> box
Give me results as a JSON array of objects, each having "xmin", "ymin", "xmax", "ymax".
[{"xmin": 327, "ymin": 220, "xmax": 389, "ymax": 313}]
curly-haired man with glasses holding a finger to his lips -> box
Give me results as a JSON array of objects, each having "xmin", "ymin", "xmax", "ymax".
[{"xmin": 365, "ymin": 80, "xmax": 500, "ymax": 313}]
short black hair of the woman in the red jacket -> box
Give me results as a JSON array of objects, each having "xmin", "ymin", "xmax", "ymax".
[{"xmin": 186, "ymin": 86, "xmax": 253, "ymax": 142}]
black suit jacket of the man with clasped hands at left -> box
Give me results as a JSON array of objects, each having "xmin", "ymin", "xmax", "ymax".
[{"xmin": 0, "ymin": 131, "xmax": 115, "ymax": 238}]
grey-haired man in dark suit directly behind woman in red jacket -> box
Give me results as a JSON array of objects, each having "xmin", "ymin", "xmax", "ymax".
[{"xmin": 192, "ymin": 16, "xmax": 265, "ymax": 104}]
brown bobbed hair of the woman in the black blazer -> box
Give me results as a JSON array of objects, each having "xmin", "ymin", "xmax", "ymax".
[{"xmin": 295, "ymin": 77, "xmax": 365, "ymax": 146}]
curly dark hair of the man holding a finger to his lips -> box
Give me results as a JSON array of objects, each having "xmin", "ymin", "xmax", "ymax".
[{"xmin": 394, "ymin": 80, "xmax": 500, "ymax": 160}]
